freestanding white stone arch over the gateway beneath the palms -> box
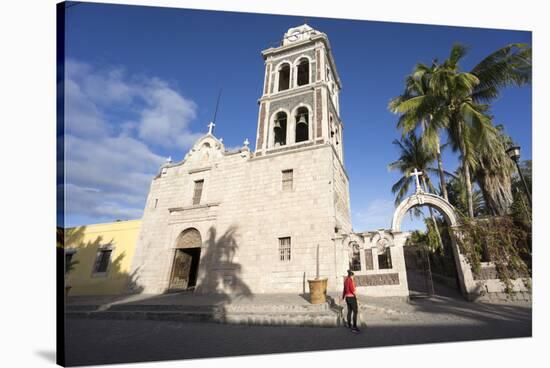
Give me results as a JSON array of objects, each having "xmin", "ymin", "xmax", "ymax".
[{"xmin": 391, "ymin": 191, "xmax": 475, "ymax": 299}]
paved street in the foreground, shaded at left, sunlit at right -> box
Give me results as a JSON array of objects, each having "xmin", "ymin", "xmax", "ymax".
[{"xmin": 66, "ymin": 296, "xmax": 532, "ymax": 366}]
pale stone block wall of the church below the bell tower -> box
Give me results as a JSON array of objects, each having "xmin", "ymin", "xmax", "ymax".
[{"xmin": 129, "ymin": 140, "xmax": 349, "ymax": 294}]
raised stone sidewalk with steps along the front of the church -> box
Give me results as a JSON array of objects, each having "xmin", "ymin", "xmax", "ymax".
[{"xmin": 65, "ymin": 292, "xmax": 342, "ymax": 327}]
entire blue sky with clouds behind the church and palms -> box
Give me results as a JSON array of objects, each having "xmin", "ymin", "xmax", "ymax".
[{"xmin": 61, "ymin": 3, "xmax": 532, "ymax": 230}]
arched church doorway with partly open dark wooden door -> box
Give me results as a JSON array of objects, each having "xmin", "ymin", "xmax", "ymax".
[{"xmin": 168, "ymin": 228, "xmax": 202, "ymax": 291}]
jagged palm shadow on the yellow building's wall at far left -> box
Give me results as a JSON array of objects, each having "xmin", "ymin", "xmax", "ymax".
[{"xmin": 62, "ymin": 226, "xmax": 143, "ymax": 295}]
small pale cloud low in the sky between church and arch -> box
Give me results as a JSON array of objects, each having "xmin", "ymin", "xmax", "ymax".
[{"xmin": 353, "ymin": 199, "xmax": 395, "ymax": 231}]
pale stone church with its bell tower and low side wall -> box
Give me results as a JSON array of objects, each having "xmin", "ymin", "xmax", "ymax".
[{"xmin": 132, "ymin": 24, "xmax": 414, "ymax": 296}]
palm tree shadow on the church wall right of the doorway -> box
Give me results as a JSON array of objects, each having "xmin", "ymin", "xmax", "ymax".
[{"xmin": 195, "ymin": 225, "xmax": 252, "ymax": 300}]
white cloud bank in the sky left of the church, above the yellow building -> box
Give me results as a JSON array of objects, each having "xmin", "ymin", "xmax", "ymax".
[{"xmin": 65, "ymin": 60, "xmax": 201, "ymax": 222}]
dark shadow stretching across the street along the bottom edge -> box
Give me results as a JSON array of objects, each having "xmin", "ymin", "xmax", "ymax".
[{"xmin": 63, "ymin": 314, "xmax": 531, "ymax": 365}]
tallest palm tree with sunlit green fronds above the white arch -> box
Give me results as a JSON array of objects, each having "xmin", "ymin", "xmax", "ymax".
[{"xmin": 389, "ymin": 44, "xmax": 531, "ymax": 217}]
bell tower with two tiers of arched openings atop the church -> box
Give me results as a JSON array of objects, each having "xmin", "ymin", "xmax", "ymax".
[{"xmin": 256, "ymin": 24, "xmax": 343, "ymax": 162}]
